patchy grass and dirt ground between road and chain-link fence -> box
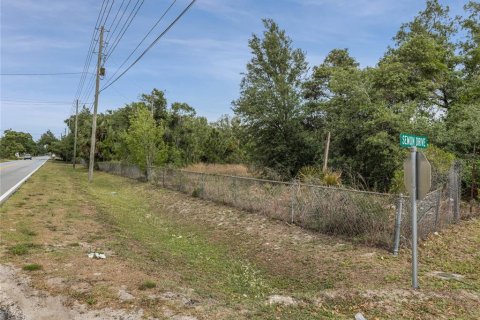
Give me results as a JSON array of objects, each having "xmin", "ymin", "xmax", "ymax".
[{"xmin": 0, "ymin": 163, "xmax": 480, "ymax": 319}]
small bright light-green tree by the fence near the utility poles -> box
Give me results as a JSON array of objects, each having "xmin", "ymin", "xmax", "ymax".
[{"xmin": 124, "ymin": 105, "xmax": 166, "ymax": 179}]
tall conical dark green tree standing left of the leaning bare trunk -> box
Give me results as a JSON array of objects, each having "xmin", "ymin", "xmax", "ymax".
[{"xmin": 233, "ymin": 19, "xmax": 311, "ymax": 176}]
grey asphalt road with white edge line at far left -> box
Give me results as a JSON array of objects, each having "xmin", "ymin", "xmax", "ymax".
[{"xmin": 0, "ymin": 157, "xmax": 48, "ymax": 203}]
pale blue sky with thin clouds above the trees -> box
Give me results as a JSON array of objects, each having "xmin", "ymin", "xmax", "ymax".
[{"xmin": 0, "ymin": 0, "xmax": 467, "ymax": 139}]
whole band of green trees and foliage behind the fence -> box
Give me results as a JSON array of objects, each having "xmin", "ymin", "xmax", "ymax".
[{"xmin": 41, "ymin": 0, "xmax": 480, "ymax": 191}]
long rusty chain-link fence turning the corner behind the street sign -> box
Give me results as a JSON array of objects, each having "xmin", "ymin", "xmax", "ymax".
[{"xmin": 98, "ymin": 163, "xmax": 468, "ymax": 251}]
